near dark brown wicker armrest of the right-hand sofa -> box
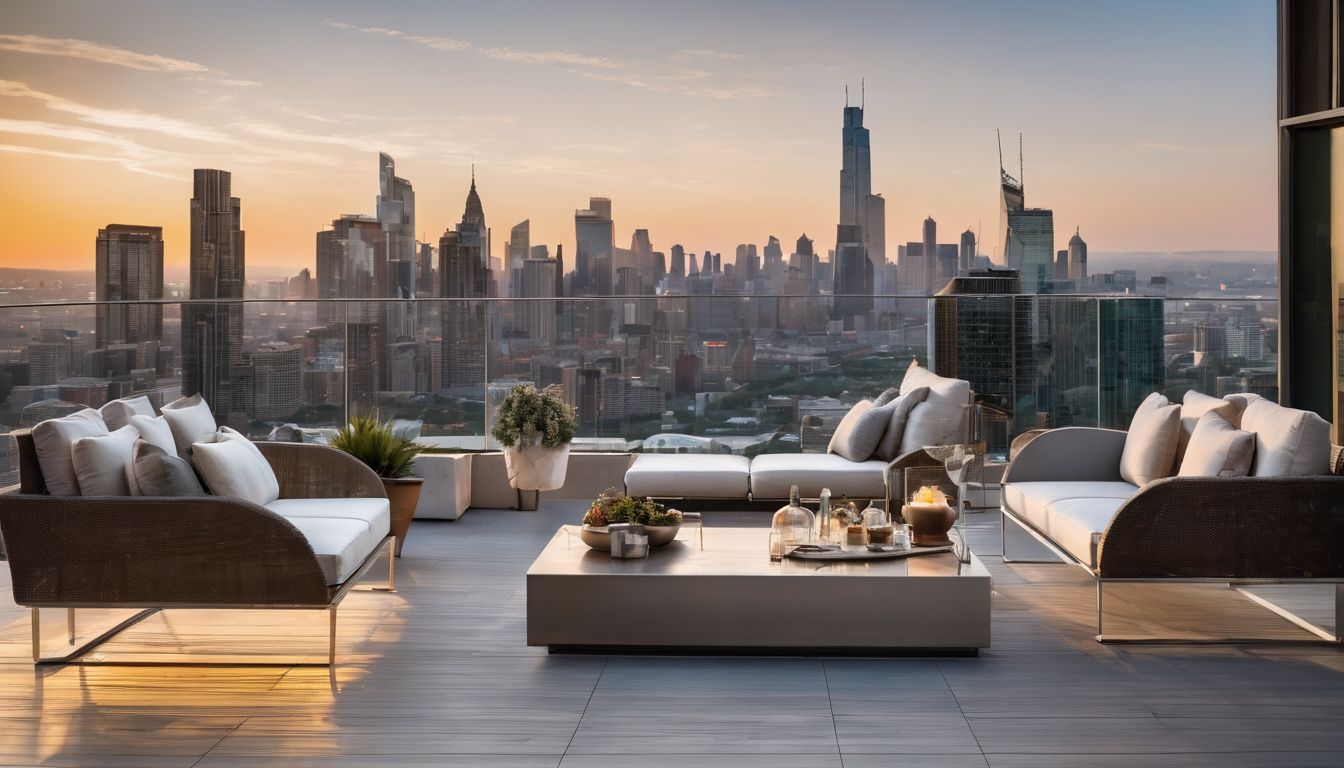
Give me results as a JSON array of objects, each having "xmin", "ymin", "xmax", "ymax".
[{"xmin": 1097, "ymin": 476, "xmax": 1344, "ymax": 580}]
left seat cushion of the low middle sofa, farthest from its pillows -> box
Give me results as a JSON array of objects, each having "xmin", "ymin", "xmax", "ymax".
[{"xmin": 625, "ymin": 453, "xmax": 751, "ymax": 499}]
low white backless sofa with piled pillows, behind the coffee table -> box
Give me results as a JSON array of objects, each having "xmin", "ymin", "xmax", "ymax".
[{"xmin": 625, "ymin": 363, "xmax": 974, "ymax": 510}]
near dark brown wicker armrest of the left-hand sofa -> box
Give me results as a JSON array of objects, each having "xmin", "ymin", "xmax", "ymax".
[{"xmin": 0, "ymin": 494, "xmax": 331, "ymax": 608}]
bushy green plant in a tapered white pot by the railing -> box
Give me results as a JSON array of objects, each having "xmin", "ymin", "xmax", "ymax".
[{"xmin": 491, "ymin": 385, "xmax": 578, "ymax": 510}]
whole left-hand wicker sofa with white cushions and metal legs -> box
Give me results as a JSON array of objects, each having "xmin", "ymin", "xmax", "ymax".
[{"xmin": 0, "ymin": 398, "xmax": 395, "ymax": 666}]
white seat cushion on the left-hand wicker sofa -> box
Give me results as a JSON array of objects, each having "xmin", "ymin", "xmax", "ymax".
[{"xmin": 266, "ymin": 498, "xmax": 391, "ymax": 585}]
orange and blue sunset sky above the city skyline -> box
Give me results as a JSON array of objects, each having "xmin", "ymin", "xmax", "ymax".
[{"xmin": 0, "ymin": 0, "xmax": 1275, "ymax": 274}]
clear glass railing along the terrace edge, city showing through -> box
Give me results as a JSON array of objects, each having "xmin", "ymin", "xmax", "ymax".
[{"xmin": 0, "ymin": 295, "xmax": 1278, "ymax": 483}]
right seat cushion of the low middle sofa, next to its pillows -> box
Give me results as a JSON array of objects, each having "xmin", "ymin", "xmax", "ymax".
[{"xmin": 751, "ymin": 453, "xmax": 887, "ymax": 499}]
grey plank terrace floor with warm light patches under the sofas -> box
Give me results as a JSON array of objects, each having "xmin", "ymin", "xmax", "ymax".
[{"xmin": 0, "ymin": 503, "xmax": 1344, "ymax": 768}]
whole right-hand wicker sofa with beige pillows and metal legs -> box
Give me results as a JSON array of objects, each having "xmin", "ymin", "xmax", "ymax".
[{"xmin": 1001, "ymin": 391, "xmax": 1344, "ymax": 643}]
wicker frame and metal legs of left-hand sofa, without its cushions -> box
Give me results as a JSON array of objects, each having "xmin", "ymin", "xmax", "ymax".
[{"xmin": 0, "ymin": 430, "xmax": 396, "ymax": 666}]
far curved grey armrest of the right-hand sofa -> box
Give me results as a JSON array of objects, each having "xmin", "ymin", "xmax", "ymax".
[{"xmin": 1003, "ymin": 426, "xmax": 1125, "ymax": 484}]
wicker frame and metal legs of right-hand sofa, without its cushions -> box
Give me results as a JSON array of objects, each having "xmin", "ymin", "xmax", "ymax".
[{"xmin": 1000, "ymin": 428, "xmax": 1344, "ymax": 644}]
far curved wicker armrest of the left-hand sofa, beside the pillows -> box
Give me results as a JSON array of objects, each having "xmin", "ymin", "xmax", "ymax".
[{"xmin": 257, "ymin": 443, "xmax": 387, "ymax": 499}]
